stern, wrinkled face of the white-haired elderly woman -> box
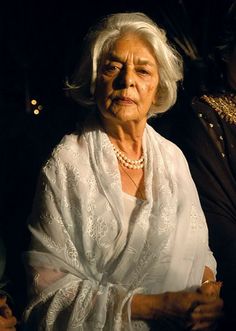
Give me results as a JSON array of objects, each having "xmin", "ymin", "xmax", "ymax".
[{"xmin": 95, "ymin": 34, "xmax": 159, "ymax": 122}]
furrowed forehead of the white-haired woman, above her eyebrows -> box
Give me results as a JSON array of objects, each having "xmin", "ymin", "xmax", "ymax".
[{"xmin": 103, "ymin": 33, "xmax": 157, "ymax": 63}]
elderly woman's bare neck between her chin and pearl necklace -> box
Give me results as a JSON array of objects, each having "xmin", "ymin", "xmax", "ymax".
[{"xmin": 101, "ymin": 118, "xmax": 146, "ymax": 159}]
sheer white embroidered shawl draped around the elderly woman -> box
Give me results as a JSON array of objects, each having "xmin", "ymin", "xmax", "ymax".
[{"xmin": 25, "ymin": 125, "xmax": 215, "ymax": 331}]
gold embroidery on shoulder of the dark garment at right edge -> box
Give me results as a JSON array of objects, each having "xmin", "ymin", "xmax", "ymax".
[{"xmin": 201, "ymin": 93, "xmax": 236, "ymax": 124}]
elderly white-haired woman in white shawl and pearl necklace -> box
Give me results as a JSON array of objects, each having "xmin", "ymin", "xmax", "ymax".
[{"xmin": 25, "ymin": 13, "xmax": 222, "ymax": 331}]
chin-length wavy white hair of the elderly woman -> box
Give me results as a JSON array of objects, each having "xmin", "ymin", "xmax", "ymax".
[{"xmin": 67, "ymin": 12, "xmax": 183, "ymax": 117}]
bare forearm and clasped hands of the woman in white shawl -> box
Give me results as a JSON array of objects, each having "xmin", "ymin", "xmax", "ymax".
[{"xmin": 131, "ymin": 291, "xmax": 223, "ymax": 330}]
